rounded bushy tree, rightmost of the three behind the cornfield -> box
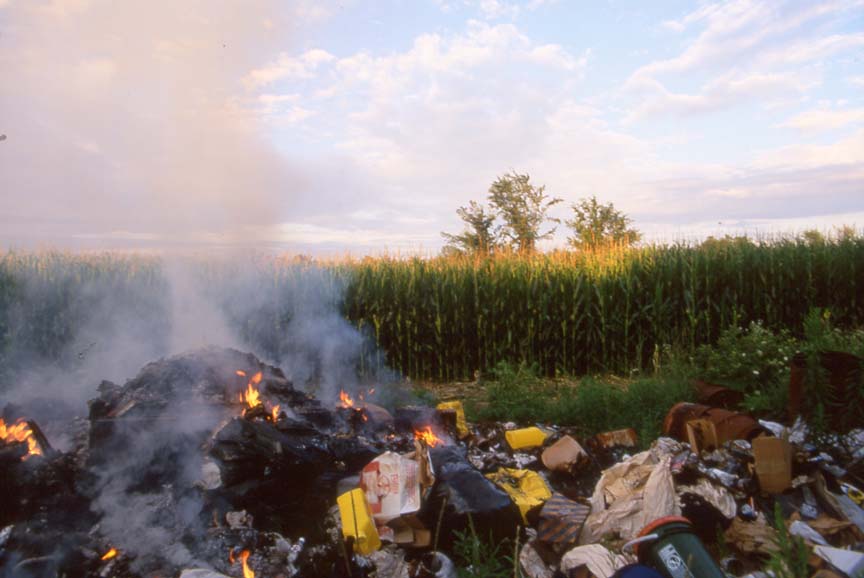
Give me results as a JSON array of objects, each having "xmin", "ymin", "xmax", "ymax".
[{"xmin": 565, "ymin": 196, "xmax": 642, "ymax": 249}]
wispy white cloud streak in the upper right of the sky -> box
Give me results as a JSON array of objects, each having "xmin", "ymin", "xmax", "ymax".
[{"xmin": 624, "ymin": 0, "xmax": 864, "ymax": 121}]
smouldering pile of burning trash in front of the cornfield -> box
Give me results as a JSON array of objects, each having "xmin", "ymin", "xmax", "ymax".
[{"xmin": 0, "ymin": 348, "xmax": 864, "ymax": 578}]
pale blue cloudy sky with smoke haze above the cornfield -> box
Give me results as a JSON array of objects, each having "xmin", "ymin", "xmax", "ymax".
[{"xmin": 0, "ymin": 0, "xmax": 864, "ymax": 255}]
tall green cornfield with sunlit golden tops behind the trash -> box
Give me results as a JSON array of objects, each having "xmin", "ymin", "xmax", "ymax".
[{"xmin": 0, "ymin": 237, "xmax": 864, "ymax": 381}]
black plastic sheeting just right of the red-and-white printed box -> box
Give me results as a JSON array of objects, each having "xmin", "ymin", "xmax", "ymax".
[{"xmin": 423, "ymin": 446, "xmax": 521, "ymax": 549}]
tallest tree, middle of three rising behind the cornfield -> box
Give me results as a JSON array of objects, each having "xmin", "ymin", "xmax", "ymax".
[{"xmin": 489, "ymin": 172, "xmax": 561, "ymax": 252}]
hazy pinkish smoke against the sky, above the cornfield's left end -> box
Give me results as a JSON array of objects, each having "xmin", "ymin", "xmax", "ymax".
[{"xmin": 0, "ymin": 0, "xmax": 318, "ymax": 247}]
